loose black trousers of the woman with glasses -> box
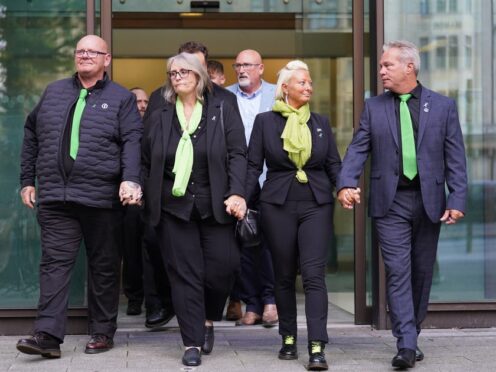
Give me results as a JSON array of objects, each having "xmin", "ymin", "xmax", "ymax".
[{"xmin": 157, "ymin": 212, "xmax": 239, "ymax": 346}]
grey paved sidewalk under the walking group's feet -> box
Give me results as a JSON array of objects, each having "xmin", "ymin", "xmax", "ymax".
[{"xmin": 0, "ymin": 302, "xmax": 496, "ymax": 372}]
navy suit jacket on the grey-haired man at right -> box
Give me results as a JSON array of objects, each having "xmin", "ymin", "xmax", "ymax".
[{"xmin": 338, "ymin": 86, "xmax": 467, "ymax": 223}]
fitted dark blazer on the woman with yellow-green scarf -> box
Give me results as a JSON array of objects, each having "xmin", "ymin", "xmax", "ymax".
[{"xmin": 246, "ymin": 111, "xmax": 341, "ymax": 204}]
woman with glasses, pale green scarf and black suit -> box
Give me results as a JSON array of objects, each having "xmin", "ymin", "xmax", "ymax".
[{"xmin": 142, "ymin": 53, "xmax": 246, "ymax": 366}]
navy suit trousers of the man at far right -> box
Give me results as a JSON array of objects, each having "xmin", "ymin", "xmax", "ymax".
[{"xmin": 374, "ymin": 190, "xmax": 441, "ymax": 350}]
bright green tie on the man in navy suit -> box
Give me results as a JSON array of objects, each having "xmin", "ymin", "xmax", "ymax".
[{"xmin": 399, "ymin": 94, "xmax": 417, "ymax": 180}]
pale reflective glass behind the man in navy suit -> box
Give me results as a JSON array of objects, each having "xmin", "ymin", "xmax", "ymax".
[{"xmin": 384, "ymin": 0, "xmax": 496, "ymax": 302}]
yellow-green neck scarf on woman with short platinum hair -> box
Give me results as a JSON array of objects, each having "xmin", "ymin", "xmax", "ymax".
[{"xmin": 272, "ymin": 100, "xmax": 312, "ymax": 183}]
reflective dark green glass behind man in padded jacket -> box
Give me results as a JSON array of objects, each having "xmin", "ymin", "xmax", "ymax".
[{"xmin": 0, "ymin": 0, "xmax": 86, "ymax": 309}]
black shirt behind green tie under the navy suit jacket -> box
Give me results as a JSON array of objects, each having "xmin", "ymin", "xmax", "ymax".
[{"xmin": 394, "ymin": 83, "xmax": 422, "ymax": 189}]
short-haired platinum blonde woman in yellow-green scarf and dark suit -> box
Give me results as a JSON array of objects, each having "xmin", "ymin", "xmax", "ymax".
[{"xmin": 246, "ymin": 61, "xmax": 341, "ymax": 370}]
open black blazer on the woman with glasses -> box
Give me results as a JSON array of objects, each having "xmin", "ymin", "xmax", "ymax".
[{"xmin": 141, "ymin": 94, "xmax": 246, "ymax": 226}]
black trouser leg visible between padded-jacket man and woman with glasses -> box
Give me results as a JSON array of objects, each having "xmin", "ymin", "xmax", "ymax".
[{"xmin": 122, "ymin": 205, "xmax": 144, "ymax": 305}]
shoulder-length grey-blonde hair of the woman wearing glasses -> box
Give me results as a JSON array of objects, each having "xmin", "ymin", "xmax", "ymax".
[{"xmin": 164, "ymin": 52, "xmax": 212, "ymax": 103}]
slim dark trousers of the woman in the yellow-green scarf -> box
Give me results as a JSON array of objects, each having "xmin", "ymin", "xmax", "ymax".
[{"xmin": 260, "ymin": 201, "xmax": 332, "ymax": 342}]
